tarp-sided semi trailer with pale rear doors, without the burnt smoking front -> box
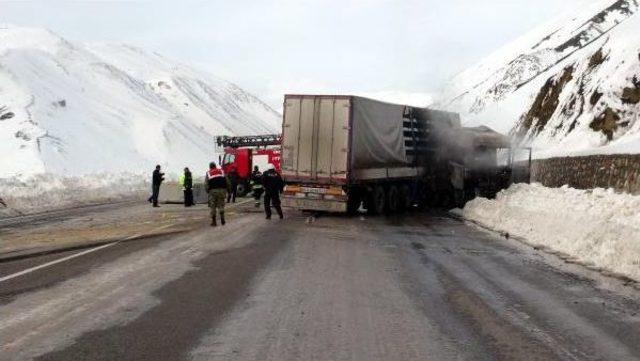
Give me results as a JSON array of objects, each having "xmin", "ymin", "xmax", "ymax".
[{"xmin": 281, "ymin": 95, "xmax": 460, "ymax": 214}]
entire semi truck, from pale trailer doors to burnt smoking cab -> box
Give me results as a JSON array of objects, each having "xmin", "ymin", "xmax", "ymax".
[{"xmin": 281, "ymin": 95, "xmax": 531, "ymax": 214}]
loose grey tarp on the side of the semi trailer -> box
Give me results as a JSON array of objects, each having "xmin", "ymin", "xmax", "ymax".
[{"xmin": 351, "ymin": 97, "xmax": 408, "ymax": 169}]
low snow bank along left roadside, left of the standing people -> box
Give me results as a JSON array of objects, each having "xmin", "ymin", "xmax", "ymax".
[{"xmin": 0, "ymin": 173, "xmax": 151, "ymax": 217}]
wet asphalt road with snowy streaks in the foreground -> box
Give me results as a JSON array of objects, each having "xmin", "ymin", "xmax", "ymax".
[{"xmin": 0, "ymin": 204, "xmax": 640, "ymax": 360}]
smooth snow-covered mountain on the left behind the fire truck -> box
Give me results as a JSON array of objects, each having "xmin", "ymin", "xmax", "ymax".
[{"xmin": 0, "ymin": 27, "xmax": 281, "ymax": 178}]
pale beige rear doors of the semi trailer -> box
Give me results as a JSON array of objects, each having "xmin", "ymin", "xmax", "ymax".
[{"xmin": 282, "ymin": 96, "xmax": 351, "ymax": 184}]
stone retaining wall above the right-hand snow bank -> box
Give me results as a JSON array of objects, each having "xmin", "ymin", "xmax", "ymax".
[{"xmin": 531, "ymin": 154, "xmax": 640, "ymax": 194}]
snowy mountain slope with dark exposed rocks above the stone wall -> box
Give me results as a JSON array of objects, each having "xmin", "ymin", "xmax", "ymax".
[{"xmin": 436, "ymin": 0, "xmax": 640, "ymax": 157}]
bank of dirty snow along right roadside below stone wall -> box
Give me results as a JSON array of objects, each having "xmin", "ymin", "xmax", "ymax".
[{"xmin": 463, "ymin": 184, "xmax": 640, "ymax": 281}]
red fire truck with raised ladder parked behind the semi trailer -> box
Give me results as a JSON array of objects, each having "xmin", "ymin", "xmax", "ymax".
[{"xmin": 216, "ymin": 134, "xmax": 282, "ymax": 197}]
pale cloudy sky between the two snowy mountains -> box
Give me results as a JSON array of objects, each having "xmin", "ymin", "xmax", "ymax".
[{"xmin": 0, "ymin": 0, "xmax": 593, "ymax": 110}]
